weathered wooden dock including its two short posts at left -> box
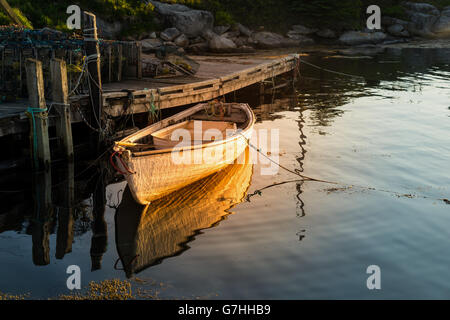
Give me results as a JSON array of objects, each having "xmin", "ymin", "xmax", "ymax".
[{"xmin": 0, "ymin": 54, "xmax": 299, "ymax": 168}]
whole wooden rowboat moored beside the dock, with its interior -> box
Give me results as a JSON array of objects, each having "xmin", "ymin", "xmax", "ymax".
[{"xmin": 113, "ymin": 102, "xmax": 255, "ymax": 205}]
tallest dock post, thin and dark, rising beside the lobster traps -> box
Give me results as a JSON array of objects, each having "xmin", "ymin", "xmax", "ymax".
[{"xmin": 83, "ymin": 11, "xmax": 103, "ymax": 137}]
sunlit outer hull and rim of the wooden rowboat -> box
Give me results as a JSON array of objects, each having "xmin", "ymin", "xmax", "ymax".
[{"xmin": 115, "ymin": 104, "xmax": 255, "ymax": 205}]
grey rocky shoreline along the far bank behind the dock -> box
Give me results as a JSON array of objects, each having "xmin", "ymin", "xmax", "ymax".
[{"xmin": 122, "ymin": 1, "xmax": 450, "ymax": 55}]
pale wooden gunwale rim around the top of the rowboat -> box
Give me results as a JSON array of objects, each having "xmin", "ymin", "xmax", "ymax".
[{"xmin": 114, "ymin": 102, "xmax": 256, "ymax": 158}]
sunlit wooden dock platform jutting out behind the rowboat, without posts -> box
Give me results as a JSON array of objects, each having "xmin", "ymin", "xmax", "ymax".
[{"xmin": 98, "ymin": 54, "xmax": 298, "ymax": 117}]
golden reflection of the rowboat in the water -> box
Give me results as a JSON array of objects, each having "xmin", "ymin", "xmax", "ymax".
[{"xmin": 115, "ymin": 147, "xmax": 253, "ymax": 277}]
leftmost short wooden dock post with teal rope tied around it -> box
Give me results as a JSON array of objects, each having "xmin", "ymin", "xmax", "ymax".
[{"xmin": 25, "ymin": 59, "xmax": 51, "ymax": 170}]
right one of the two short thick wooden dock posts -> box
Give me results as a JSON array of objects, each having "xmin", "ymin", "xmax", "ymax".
[{"xmin": 50, "ymin": 59, "xmax": 73, "ymax": 161}]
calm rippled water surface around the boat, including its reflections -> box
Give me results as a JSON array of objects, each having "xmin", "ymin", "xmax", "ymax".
[{"xmin": 0, "ymin": 49, "xmax": 450, "ymax": 299}]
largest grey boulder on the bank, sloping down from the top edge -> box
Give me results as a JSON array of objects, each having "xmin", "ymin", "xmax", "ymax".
[{"xmin": 149, "ymin": 1, "xmax": 214, "ymax": 37}]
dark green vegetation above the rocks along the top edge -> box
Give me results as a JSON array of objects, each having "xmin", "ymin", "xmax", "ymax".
[{"xmin": 0, "ymin": 0, "xmax": 450, "ymax": 36}]
